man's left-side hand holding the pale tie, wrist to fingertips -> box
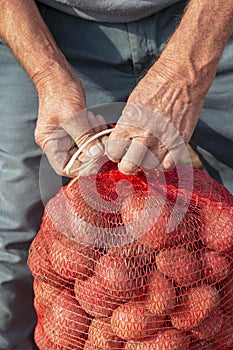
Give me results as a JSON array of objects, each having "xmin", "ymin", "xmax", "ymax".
[{"xmin": 35, "ymin": 63, "xmax": 105, "ymax": 177}]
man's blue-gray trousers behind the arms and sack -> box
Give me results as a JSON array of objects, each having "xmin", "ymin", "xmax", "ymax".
[{"xmin": 0, "ymin": 1, "xmax": 233, "ymax": 350}]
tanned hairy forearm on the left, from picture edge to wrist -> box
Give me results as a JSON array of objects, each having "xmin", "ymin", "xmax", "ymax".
[{"xmin": 0, "ymin": 0, "xmax": 72, "ymax": 85}]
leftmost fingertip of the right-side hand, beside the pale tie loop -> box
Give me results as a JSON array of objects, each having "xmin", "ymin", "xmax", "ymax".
[{"xmin": 105, "ymin": 138, "xmax": 131, "ymax": 163}]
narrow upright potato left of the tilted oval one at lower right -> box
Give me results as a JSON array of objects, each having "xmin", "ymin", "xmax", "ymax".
[{"xmin": 144, "ymin": 271, "xmax": 176, "ymax": 315}]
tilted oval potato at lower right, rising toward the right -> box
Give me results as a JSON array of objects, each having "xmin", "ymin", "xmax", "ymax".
[{"xmin": 170, "ymin": 285, "xmax": 220, "ymax": 331}]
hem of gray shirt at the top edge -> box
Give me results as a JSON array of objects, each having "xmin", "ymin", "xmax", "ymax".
[{"xmin": 39, "ymin": 0, "xmax": 179, "ymax": 23}]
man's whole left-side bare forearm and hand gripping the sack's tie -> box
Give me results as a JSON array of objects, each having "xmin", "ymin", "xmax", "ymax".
[{"xmin": 0, "ymin": 0, "xmax": 104, "ymax": 176}]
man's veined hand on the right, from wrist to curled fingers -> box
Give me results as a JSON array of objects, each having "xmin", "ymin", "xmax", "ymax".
[{"xmin": 107, "ymin": 67, "xmax": 203, "ymax": 174}]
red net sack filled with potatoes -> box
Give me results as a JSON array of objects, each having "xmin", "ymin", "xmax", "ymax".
[{"xmin": 28, "ymin": 162, "xmax": 233, "ymax": 350}]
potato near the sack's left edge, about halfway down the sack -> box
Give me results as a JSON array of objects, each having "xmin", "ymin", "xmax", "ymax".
[{"xmin": 49, "ymin": 240, "xmax": 95, "ymax": 279}]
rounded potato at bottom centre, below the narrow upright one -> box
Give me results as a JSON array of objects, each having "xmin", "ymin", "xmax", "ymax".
[{"xmin": 111, "ymin": 302, "xmax": 164, "ymax": 340}]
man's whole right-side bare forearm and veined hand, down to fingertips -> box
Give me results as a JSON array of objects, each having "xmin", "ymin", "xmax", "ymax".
[{"xmin": 107, "ymin": 0, "xmax": 233, "ymax": 174}]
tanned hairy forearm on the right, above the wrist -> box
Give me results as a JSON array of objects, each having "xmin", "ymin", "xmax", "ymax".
[{"xmin": 152, "ymin": 0, "xmax": 233, "ymax": 94}]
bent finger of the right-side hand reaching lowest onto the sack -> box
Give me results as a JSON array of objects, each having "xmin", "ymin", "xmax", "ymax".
[{"xmin": 118, "ymin": 139, "xmax": 148, "ymax": 174}]
